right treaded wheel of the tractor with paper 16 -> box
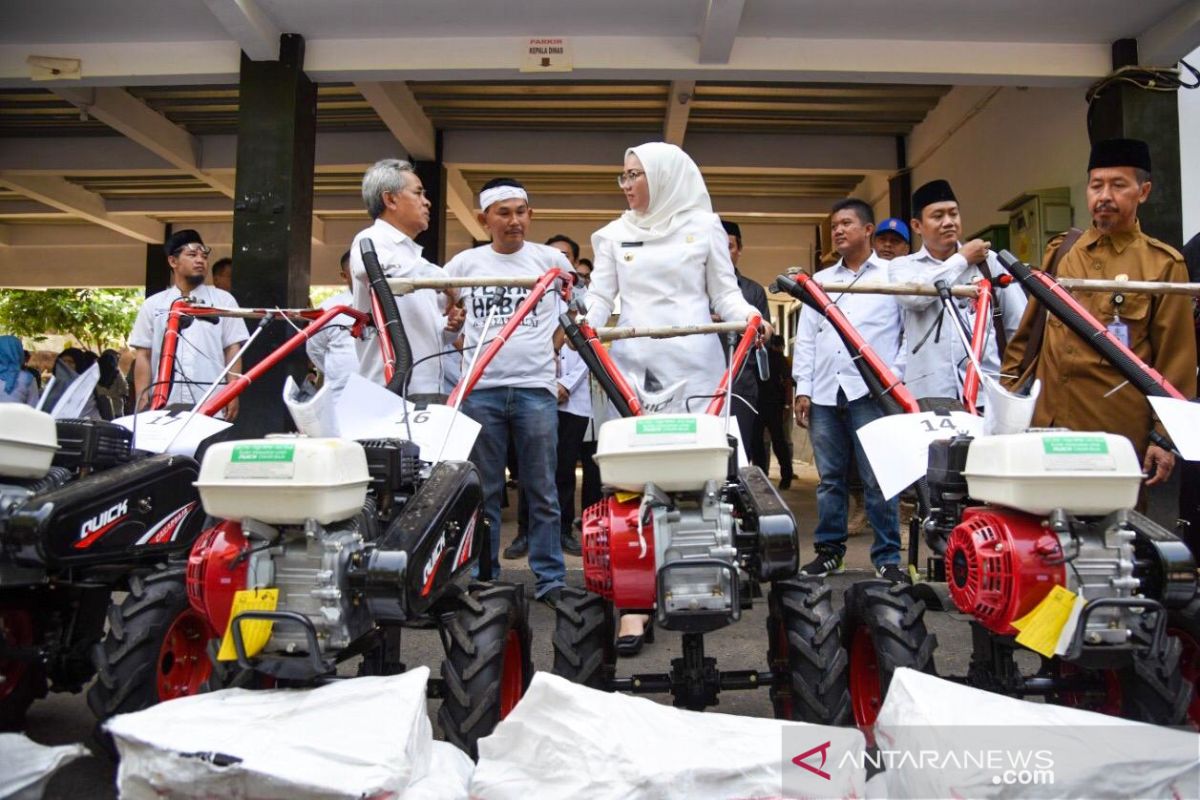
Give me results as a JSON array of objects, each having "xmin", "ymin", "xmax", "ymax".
[{"xmin": 438, "ymin": 583, "xmax": 533, "ymax": 758}]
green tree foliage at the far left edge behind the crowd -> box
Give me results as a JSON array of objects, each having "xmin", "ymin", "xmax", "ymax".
[{"xmin": 0, "ymin": 289, "xmax": 143, "ymax": 353}]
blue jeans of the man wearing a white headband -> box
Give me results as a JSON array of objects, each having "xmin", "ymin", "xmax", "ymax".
[{"xmin": 462, "ymin": 387, "xmax": 566, "ymax": 597}]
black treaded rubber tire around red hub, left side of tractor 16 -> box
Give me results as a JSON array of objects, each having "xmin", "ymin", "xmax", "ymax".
[{"xmin": 88, "ymin": 569, "xmax": 212, "ymax": 721}]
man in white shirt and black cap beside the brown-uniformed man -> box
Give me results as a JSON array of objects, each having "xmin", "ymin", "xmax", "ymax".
[{"xmin": 889, "ymin": 180, "xmax": 1026, "ymax": 399}]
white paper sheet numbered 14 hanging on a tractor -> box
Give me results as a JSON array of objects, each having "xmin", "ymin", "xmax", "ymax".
[{"xmin": 858, "ymin": 411, "xmax": 983, "ymax": 499}]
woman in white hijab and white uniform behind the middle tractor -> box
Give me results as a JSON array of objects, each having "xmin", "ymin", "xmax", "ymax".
[{"xmin": 587, "ymin": 142, "xmax": 757, "ymax": 655}]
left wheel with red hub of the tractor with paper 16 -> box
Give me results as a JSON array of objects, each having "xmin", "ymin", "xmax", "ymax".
[{"xmin": 88, "ymin": 570, "xmax": 216, "ymax": 720}]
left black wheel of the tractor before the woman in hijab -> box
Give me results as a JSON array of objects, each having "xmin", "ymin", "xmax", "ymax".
[{"xmin": 553, "ymin": 587, "xmax": 617, "ymax": 690}]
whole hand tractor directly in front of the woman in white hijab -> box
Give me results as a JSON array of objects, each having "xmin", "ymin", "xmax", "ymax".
[{"xmin": 553, "ymin": 315, "xmax": 864, "ymax": 723}]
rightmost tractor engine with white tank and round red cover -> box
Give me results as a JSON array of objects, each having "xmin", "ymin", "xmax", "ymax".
[{"xmin": 928, "ymin": 431, "xmax": 1195, "ymax": 645}]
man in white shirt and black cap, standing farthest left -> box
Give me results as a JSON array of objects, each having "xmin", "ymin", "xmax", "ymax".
[{"xmin": 130, "ymin": 229, "xmax": 248, "ymax": 422}]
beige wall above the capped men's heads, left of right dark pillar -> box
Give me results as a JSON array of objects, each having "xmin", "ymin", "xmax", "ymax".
[{"xmin": 902, "ymin": 86, "xmax": 1090, "ymax": 241}]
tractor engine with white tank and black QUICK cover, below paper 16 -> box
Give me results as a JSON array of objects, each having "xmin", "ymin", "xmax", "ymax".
[{"xmin": 187, "ymin": 438, "xmax": 481, "ymax": 657}]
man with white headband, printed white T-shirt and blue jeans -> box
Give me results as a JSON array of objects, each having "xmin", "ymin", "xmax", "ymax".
[{"xmin": 445, "ymin": 178, "xmax": 571, "ymax": 604}]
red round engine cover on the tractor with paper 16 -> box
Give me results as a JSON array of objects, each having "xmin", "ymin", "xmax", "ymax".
[{"xmin": 187, "ymin": 519, "xmax": 250, "ymax": 634}]
